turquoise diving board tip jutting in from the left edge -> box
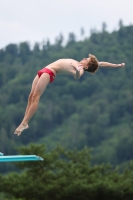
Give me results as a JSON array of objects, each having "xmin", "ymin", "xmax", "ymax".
[{"xmin": 0, "ymin": 152, "xmax": 43, "ymax": 162}]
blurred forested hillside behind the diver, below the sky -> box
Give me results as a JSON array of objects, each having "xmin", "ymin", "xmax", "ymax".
[{"xmin": 0, "ymin": 23, "xmax": 133, "ymax": 177}]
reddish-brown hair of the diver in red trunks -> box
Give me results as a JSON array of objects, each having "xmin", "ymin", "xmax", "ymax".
[{"xmin": 85, "ymin": 54, "xmax": 98, "ymax": 73}]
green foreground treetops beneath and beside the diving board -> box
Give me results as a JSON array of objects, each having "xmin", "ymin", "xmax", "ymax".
[{"xmin": 0, "ymin": 144, "xmax": 133, "ymax": 200}]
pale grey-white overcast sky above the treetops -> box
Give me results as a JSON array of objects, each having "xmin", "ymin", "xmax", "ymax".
[{"xmin": 0, "ymin": 0, "xmax": 133, "ymax": 49}]
